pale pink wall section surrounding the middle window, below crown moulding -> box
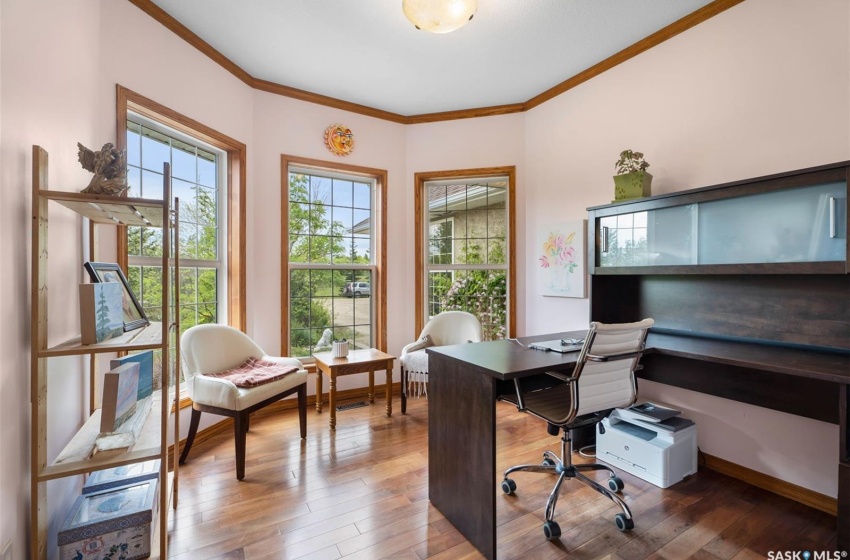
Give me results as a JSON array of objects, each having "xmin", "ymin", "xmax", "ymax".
[{"xmin": 248, "ymin": 91, "xmax": 409, "ymax": 392}]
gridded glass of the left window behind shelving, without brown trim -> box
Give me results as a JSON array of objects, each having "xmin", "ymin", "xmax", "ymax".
[{"xmin": 127, "ymin": 115, "xmax": 226, "ymax": 382}]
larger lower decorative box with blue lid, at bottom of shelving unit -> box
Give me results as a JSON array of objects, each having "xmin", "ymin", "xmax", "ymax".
[{"xmin": 59, "ymin": 480, "xmax": 159, "ymax": 560}]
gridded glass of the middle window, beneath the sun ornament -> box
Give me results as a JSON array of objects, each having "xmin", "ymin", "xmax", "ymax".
[{"xmin": 287, "ymin": 169, "xmax": 374, "ymax": 357}]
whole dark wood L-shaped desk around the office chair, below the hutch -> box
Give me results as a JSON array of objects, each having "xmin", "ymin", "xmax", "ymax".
[{"xmin": 428, "ymin": 332, "xmax": 850, "ymax": 558}]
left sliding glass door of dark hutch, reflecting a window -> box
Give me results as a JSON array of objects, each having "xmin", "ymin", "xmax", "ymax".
[{"xmin": 598, "ymin": 204, "xmax": 697, "ymax": 267}]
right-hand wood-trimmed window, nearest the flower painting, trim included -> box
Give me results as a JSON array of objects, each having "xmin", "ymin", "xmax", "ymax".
[{"xmin": 416, "ymin": 167, "xmax": 515, "ymax": 340}]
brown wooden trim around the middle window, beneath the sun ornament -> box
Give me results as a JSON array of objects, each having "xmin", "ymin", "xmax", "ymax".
[{"xmin": 280, "ymin": 154, "xmax": 388, "ymax": 356}]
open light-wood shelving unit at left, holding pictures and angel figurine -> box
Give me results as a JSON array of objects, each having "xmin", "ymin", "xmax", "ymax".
[{"xmin": 31, "ymin": 146, "xmax": 180, "ymax": 560}]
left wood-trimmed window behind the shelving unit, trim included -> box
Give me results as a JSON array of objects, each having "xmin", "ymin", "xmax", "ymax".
[{"xmin": 116, "ymin": 86, "xmax": 247, "ymax": 394}]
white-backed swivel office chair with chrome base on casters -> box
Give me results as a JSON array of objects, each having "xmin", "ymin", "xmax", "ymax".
[{"xmin": 500, "ymin": 319, "xmax": 654, "ymax": 540}]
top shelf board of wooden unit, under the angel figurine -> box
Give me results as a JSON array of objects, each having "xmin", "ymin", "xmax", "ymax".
[{"xmin": 41, "ymin": 190, "xmax": 166, "ymax": 228}]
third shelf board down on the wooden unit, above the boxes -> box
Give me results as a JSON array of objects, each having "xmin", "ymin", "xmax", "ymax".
[{"xmin": 38, "ymin": 391, "xmax": 174, "ymax": 482}]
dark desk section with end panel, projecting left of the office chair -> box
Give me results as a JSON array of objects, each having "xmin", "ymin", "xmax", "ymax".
[{"xmin": 427, "ymin": 331, "xmax": 585, "ymax": 559}]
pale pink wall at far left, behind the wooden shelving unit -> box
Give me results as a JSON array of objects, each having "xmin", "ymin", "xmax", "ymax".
[{"xmin": 0, "ymin": 0, "xmax": 103, "ymax": 558}]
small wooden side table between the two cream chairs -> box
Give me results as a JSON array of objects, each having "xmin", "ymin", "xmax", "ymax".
[{"xmin": 313, "ymin": 348, "xmax": 395, "ymax": 430}]
